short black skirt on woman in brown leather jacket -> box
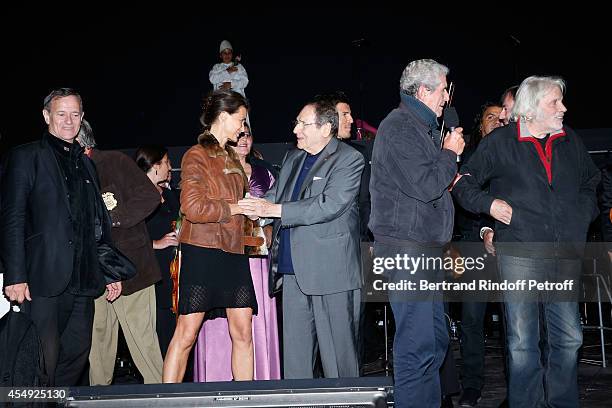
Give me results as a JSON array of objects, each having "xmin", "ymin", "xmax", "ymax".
[{"xmin": 179, "ymin": 244, "xmax": 257, "ymax": 320}]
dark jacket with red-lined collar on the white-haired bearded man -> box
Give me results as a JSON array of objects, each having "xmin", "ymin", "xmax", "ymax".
[{"xmin": 453, "ymin": 123, "xmax": 600, "ymax": 255}]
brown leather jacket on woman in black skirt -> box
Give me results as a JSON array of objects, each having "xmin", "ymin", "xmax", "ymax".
[{"xmin": 179, "ymin": 132, "xmax": 256, "ymax": 254}]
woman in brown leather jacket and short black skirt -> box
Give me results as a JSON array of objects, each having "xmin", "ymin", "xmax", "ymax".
[{"xmin": 163, "ymin": 90, "xmax": 257, "ymax": 383}]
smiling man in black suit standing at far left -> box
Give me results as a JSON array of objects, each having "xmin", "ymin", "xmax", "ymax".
[{"xmin": 0, "ymin": 88, "xmax": 121, "ymax": 386}]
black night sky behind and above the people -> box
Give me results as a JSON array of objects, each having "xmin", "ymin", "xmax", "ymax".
[{"xmin": 0, "ymin": 7, "xmax": 612, "ymax": 152}]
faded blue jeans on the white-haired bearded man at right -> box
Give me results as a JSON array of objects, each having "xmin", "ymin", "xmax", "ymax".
[{"xmin": 498, "ymin": 255, "xmax": 582, "ymax": 408}]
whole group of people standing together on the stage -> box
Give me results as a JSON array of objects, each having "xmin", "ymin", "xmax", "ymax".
[{"xmin": 0, "ymin": 40, "xmax": 600, "ymax": 408}]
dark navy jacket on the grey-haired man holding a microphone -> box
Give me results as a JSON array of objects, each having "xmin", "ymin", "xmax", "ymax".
[{"xmin": 369, "ymin": 98, "xmax": 457, "ymax": 246}]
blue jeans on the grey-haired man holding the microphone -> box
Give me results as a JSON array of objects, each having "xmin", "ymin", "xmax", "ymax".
[{"xmin": 374, "ymin": 243, "xmax": 449, "ymax": 408}]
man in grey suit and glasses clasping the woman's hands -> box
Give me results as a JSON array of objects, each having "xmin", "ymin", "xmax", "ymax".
[{"xmin": 238, "ymin": 100, "xmax": 364, "ymax": 378}]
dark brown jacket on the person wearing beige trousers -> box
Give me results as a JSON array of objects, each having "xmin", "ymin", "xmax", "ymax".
[{"xmin": 91, "ymin": 149, "xmax": 161, "ymax": 295}]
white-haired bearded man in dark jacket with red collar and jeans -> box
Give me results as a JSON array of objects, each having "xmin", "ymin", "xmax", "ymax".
[{"xmin": 453, "ymin": 76, "xmax": 600, "ymax": 407}]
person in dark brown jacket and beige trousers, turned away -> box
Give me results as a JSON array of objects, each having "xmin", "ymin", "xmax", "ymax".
[{"xmin": 77, "ymin": 120, "xmax": 163, "ymax": 385}]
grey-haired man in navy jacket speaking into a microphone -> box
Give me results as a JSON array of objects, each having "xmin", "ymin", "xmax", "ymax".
[{"xmin": 369, "ymin": 59, "xmax": 465, "ymax": 408}]
